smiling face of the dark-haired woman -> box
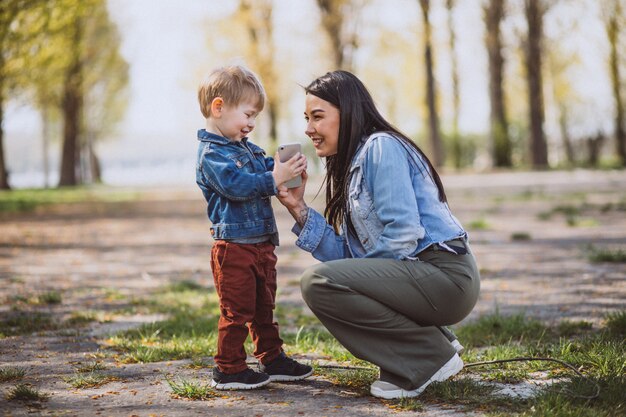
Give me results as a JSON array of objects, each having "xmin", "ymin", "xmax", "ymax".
[{"xmin": 304, "ymin": 94, "xmax": 339, "ymax": 157}]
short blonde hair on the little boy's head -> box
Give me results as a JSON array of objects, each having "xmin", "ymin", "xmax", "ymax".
[{"xmin": 198, "ymin": 65, "xmax": 265, "ymax": 119}]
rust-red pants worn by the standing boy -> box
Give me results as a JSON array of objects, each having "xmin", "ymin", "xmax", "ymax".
[{"xmin": 211, "ymin": 240, "xmax": 283, "ymax": 374}]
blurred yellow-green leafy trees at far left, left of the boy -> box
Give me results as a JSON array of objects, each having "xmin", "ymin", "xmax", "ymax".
[{"xmin": 0, "ymin": 0, "xmax": 128, "ymax": 189}]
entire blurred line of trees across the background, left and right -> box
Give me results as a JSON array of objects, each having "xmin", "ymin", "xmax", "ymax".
[{"xmin": 0, "ymin": 0, "xmax": 626, "ymax": 188}]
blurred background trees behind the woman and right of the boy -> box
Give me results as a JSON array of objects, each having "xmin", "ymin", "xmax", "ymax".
[{"xmin": 207, "ymin": 0, "xmax": 626, "ymax": 169}]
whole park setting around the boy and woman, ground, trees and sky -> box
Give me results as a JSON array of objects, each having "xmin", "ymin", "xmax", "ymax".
[{"xmin": 0, "ymin": 0, "xmax": 626, "ymax": 417}]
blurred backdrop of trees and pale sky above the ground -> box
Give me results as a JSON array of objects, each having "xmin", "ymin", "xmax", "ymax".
[{"xmin": 0, "ymin": 0, "xmax": 626, "ymax": 187}]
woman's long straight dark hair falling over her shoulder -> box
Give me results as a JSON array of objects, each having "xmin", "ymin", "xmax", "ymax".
[{"xmin": 304, "ymin": 71, "xmax": 447, "ymax": 231}]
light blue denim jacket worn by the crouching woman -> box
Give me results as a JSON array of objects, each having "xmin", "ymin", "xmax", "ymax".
[{"xmin": 292, "ymin": 132, "xmax": 467, "ymax": 262}]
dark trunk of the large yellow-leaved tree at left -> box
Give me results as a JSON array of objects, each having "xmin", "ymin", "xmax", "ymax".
[{"xmin": 59, "ymin": 19, "xmax": 83, "ymax": 187}]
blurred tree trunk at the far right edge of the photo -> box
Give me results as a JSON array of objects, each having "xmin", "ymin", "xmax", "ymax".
[{"xmin": 607, "ymin": 0, "xmax": 626, "ymax": 167}]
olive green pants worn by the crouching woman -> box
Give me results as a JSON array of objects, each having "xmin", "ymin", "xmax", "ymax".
[{"xmin": 301, "ymin": 244, "xmax": 480, "ymax": 390}]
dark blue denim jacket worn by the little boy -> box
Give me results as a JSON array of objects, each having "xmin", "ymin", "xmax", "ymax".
[{"xmin": 196, "ymin": 129, "xmax": 277, "ymax": 240}]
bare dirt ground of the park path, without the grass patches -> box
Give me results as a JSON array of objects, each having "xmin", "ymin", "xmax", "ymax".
[{"xmin": 0, "ymin": 171, "xmax": 626, "ymax": 417}]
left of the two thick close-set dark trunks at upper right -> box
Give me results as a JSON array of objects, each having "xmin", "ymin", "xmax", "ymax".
[{"xmin": 484, "ymin": 0, "xmax": 512, "ymax": 167}]
